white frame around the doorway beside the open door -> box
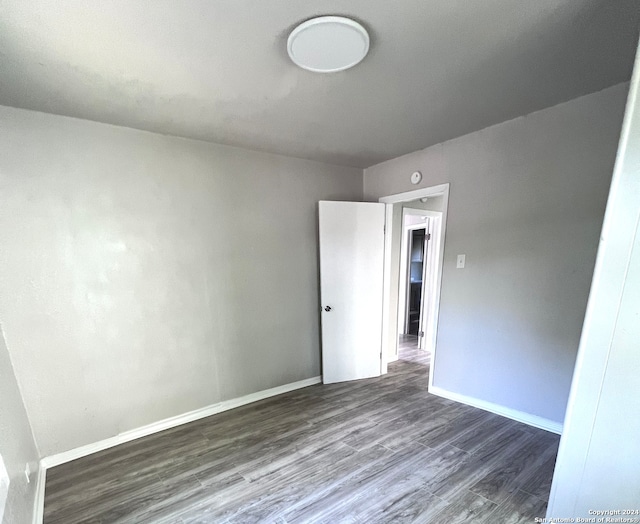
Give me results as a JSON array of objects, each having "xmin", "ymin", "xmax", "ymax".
[{"xmin": 378, "ymin": 183, "xmax": 450, "ymax": 389}]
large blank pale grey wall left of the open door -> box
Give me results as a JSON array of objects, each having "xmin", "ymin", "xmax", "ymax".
[{"xmin": 0, "ymin": 107, "xmax": 362, "ymax": 456}]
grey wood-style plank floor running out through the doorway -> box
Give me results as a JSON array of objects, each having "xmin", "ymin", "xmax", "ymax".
[{"xmin": 45, "ymin": 339, "xmax": 559, "ymax": 524}]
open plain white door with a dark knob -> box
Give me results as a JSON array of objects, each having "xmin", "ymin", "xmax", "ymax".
[{"xmin": 319, "ymin": 201, "xmax": 385, "ymax": 384}]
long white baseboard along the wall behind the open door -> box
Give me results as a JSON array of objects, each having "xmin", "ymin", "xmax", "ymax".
[{"xmin": 40, "ymin": 377, "xmax": 322, "ymax": 468}]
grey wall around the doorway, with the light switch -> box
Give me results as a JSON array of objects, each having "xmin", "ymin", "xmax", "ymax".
[{"xmin": 364, "ymin": 84, "xmax": 628, "ymax": 424}]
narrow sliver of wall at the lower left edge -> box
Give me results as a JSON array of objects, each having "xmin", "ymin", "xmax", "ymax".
[{"xmin": 0, "ymin": 326, "xmax": 39, "ymax": 524}]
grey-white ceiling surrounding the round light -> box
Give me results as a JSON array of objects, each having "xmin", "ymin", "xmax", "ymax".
[{"xmin": 0, "ymin": 0, "xmax": 640, "ymax": 167}]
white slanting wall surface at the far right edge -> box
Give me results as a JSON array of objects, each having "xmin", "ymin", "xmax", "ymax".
[{"xmin": 547, "ymin": 40, "xmax": 640, "ymax": 522}]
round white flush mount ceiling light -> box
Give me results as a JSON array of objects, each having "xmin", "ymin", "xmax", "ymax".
[{"xmin": 287, "ymin": 16, "xmax": 369, "ymax": 73}]
